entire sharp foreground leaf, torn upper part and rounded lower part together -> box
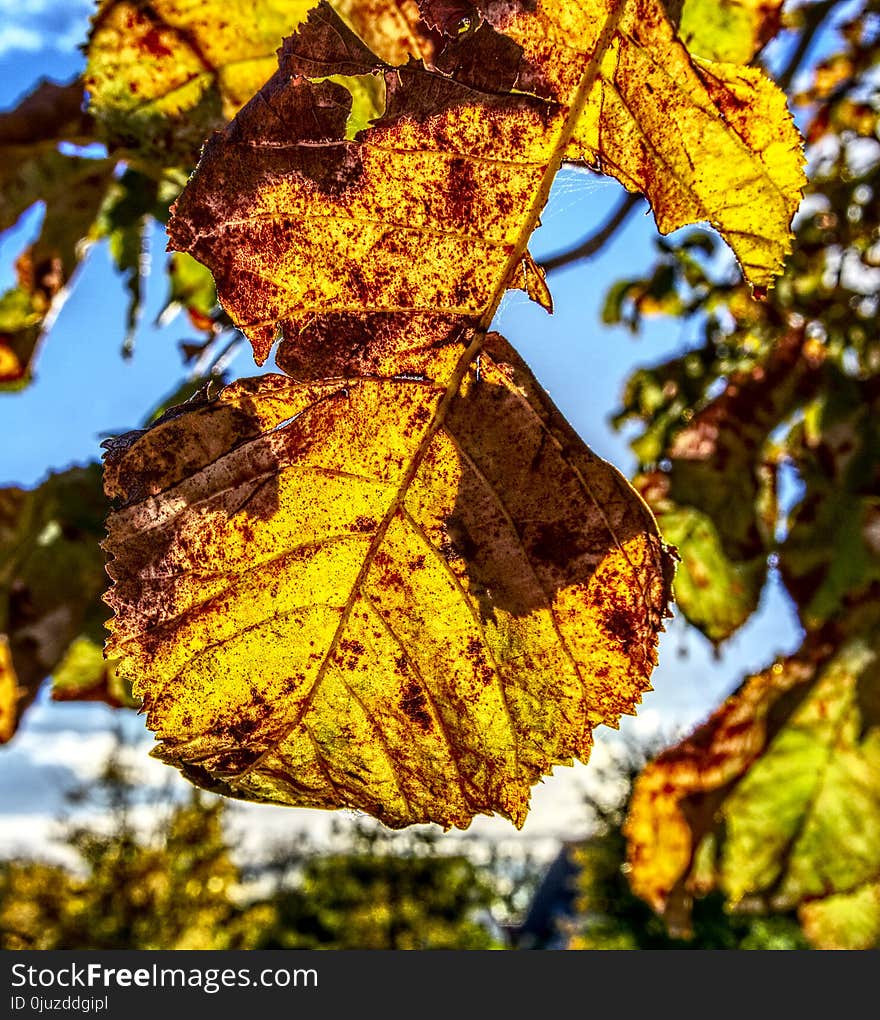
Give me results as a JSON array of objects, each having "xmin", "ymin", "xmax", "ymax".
[{"xmin": 97, "ymin": 3, "xmax": 801, "ymax": 826}]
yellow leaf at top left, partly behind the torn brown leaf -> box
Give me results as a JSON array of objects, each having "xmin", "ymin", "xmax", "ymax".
[{"xmin": 86, "ymin": 0, "xmax": 429, "ymax": 163}]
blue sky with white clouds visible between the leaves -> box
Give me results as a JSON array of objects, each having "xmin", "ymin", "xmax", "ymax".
[{"xmin": 0, "ymin": 0, "xmax": 819, "ymax": 854}]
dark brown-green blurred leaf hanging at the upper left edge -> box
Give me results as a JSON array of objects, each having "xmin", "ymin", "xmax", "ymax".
[{"xmin": 0, "ymin": 82, "xmax": 112, "ymax": 388}]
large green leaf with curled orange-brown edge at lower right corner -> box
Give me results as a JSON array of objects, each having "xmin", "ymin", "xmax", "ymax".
[{"xmin": 626, "ymin": 610, "xmax": 880, "ymax": 949}]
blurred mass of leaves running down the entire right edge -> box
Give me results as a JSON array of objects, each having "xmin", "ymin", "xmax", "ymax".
[{"xmin": 619, "ymin": 2, "xmax": 880, "ymax": 949}]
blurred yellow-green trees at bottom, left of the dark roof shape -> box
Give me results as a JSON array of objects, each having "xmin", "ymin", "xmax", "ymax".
[{"xmin": 0, "ymin": 749, "xmax": 533, "ymax": 950}]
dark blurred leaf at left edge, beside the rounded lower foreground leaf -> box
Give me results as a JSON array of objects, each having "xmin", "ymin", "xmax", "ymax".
[{"xmin": 0, "ymin": 465, "xmax": 106, "ymax": 743}]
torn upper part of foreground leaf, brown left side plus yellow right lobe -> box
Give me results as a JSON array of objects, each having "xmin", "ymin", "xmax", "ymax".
[{"xmin": 169, "ymin": 0, "xmax": 803, "ymax": 374}]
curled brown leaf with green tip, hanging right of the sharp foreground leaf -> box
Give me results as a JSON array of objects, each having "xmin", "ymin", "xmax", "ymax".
[{"xmin": 632, "ymin": 330, "xmax": 820, "ymax": 643}]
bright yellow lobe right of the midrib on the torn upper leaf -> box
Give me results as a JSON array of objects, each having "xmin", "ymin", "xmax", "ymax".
[{"xmin": 469, "ymin": 0, "xmax": 806, "ymax": 289}]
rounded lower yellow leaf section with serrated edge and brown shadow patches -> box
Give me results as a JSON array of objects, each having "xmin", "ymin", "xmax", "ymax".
[{"xmin": 105, "ymin": 336, "xmax": 668, "ymax": 827}]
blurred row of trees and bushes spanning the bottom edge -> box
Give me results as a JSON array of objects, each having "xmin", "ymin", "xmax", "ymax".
[{"xmin": 0, "ymin": 744, "xmax": 809, "ymax": 950}]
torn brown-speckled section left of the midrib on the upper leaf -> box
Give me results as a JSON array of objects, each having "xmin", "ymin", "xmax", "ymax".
[{"xmin": 168, "ymin": 3, "xmax": 571, "ymax": 369}]
